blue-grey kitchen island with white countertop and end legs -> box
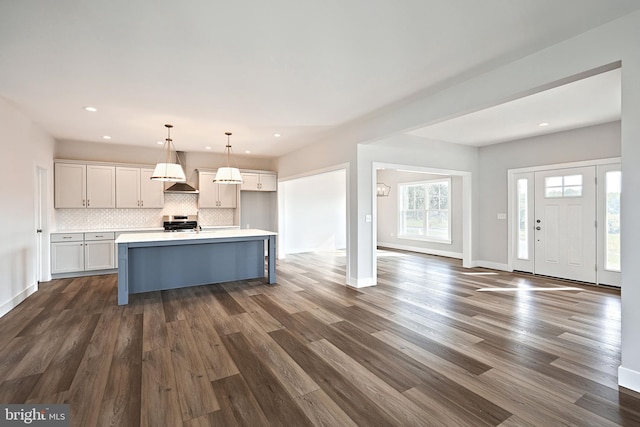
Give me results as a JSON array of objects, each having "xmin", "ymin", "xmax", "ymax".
[{"xmin": 116, "ymin": 229, "xmax": 276, "ymax": 305}]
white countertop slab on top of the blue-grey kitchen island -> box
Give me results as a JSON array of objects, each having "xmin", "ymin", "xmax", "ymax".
[{"xmin": 116, "ymin": 228, "xmax": 278, "ymax": 243}]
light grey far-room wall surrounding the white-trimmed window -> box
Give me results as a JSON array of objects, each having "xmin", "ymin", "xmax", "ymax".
[{"xmin": 376, "ymin": 169, "xmax": 462, "ymax": 258}]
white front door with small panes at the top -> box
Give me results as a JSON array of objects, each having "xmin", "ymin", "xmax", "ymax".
[{"xmin": 534, "ymin": 166, "xmax": 596, "ymax": 283}]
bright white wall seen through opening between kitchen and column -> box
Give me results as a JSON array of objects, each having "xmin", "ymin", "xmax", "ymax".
[{"xmin": 279, "ymin": 170, "xmax": 347, "ymax": 254}]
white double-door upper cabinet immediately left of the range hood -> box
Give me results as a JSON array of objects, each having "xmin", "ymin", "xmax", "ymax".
[{"xmin": 116, "ymin": 167, "xmax": 164, "ymax": 208}]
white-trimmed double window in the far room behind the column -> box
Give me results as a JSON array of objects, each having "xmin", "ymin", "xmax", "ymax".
[{"xmin": 398, "ymin": 178, "xmax": 451, "ymax": 243}]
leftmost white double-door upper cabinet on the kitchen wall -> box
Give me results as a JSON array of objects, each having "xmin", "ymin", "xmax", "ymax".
[{"xmin": 54, "ymin": 163, "xmax": 116, "ymax": 208}]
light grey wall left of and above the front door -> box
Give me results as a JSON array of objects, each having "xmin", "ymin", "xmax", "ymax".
[{"xmin": 477, "ymin": 122, "xmax": 621, "ymax": 266}]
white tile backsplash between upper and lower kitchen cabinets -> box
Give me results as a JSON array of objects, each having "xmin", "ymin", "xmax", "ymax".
[{"xmin": 55, "ymin": 193, "xmax": 234, "ymax": 231}]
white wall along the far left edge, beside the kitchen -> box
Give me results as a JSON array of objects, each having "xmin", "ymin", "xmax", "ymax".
[{"xmin": 0, "ymin": 98, "xmax": 54, "ymax": 316}]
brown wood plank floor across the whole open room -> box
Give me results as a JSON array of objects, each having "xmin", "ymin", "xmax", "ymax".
[{"xmin": 0, "ymin": 251, "xmax": 640, "ymax": 427}]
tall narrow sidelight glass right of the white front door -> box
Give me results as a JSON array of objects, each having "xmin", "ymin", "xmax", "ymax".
[{"xmin": 604, "ymin": 171, "xmax": 622, "ymax": 271}]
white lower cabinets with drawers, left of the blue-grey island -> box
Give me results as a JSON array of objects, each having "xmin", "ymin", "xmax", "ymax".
[{"xmin": 51, "ymin": 232, "xmax": 116, "ymax": 274}]
